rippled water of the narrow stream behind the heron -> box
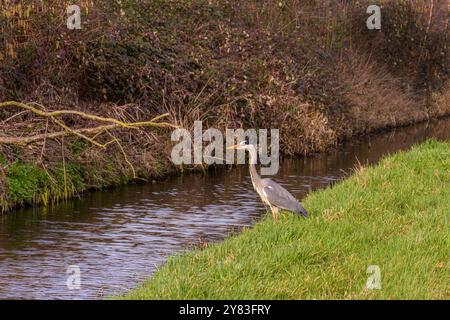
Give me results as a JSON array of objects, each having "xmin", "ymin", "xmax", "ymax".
[{"xmin": 0, "ymin": 119, "xmax": 450, "ymax": 299}]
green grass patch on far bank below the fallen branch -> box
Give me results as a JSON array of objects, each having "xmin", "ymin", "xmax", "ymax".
[{"xmin": 0, "ymin": 151, "xmax": 162, "ymax": 215}]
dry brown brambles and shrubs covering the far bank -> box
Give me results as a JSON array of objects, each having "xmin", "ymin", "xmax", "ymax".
[{"xmin": 0, "ymin": 0, "xmax": 450, "ymax": 212}]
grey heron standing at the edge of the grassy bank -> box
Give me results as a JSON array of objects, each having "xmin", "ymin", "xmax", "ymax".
[{"xmin": 228, "ymin": 141, "xmax": 308, "ymax": 223}]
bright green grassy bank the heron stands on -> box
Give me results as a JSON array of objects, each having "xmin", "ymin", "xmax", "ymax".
[{"xmin": 124, "ymin": 140, "xmax": 450, "ymax": 299}]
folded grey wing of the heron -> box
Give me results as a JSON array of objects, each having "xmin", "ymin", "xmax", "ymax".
[{"xmin": 261, "ymin": 179, "xmax": 308, "ymax": 216}]
